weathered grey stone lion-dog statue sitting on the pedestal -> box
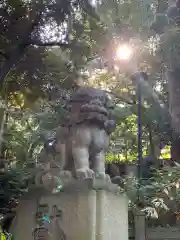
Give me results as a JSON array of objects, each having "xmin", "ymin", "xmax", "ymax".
[{"xmin": 35, "ymin": 87, "xmax": 115, "ymax": 188}]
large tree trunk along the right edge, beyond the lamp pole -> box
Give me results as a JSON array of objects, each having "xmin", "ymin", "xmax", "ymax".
[{"xmin": 153, "ymin": 0, "xmax": 180, "ymax": 162}]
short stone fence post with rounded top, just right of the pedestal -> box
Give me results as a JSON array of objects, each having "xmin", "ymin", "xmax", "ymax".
[{"xmin": 134, "ymin": 210, "xmax": 146, "ymax": 240}]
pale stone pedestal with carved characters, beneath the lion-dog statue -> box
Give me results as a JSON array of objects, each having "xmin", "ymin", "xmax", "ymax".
[{"xmin": 11, "ymin": 180, "xmax": 128, "ymax": 240}]
